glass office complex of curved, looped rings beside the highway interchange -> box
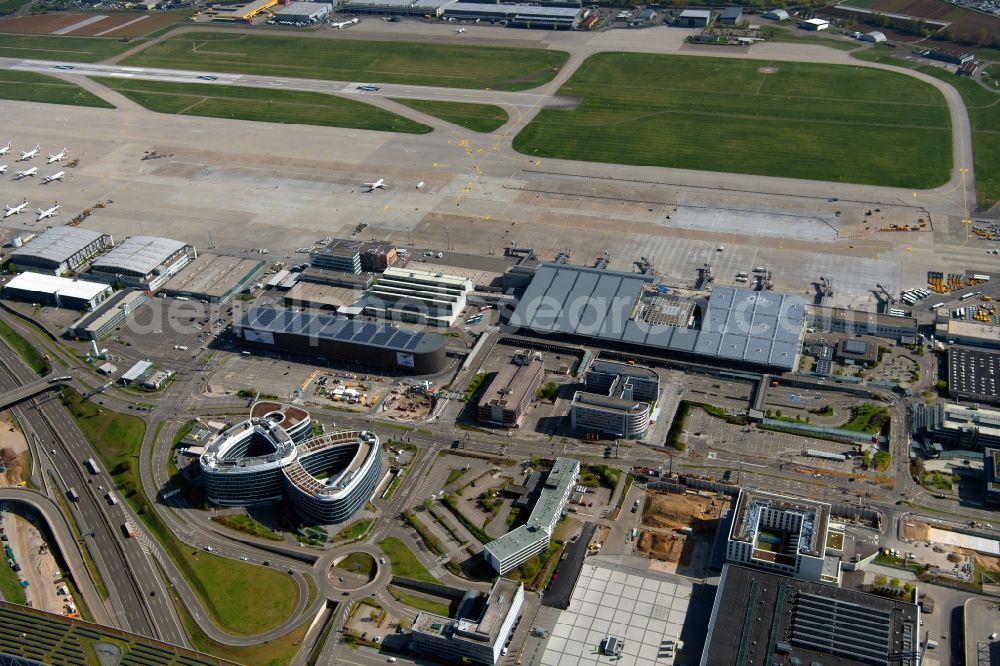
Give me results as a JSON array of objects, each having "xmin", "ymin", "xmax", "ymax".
[{"xmin": 199, "ymin": 402, "xmax": 382, "ymax": 524}]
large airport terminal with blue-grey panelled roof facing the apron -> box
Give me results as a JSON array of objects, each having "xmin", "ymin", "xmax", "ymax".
[{"xmin": 510, "ymin": 263, "xmax": 806, "ymax": 371}]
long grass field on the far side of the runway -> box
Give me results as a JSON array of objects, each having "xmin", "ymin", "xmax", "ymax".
[{"xmin": 123, "ymin": 32, "xmax": 568, "ymax": 90}]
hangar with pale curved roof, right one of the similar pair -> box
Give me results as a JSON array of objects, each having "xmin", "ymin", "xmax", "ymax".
[{"xmin": 90, "ymin": 236, "xmax": 198, "ymax": 291}]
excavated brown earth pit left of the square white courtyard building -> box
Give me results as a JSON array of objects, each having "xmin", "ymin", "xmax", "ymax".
[{"xmin": 636, "ymin": 491, "xmax": 729, "ymax": 575}]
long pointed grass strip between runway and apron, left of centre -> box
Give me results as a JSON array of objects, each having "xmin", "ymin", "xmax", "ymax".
[{"xmin": 94, "ymin": 77, "xmax": 431, "ymax": 134}]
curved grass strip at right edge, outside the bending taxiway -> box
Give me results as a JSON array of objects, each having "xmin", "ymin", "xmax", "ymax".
[{"xmin": 918, "ymin": 67, "xmax": 1000, "ymax": 208}]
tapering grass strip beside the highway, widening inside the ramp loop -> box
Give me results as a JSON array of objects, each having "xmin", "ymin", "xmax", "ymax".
[{"xmin": 63, "ymin": 388, "xmax": 298, "ymax": 636}]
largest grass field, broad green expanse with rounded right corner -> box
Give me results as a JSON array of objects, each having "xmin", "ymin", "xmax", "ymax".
[{"xmin": 514, "ymin": 53, "xmax": 951, "ymax": 189}]
